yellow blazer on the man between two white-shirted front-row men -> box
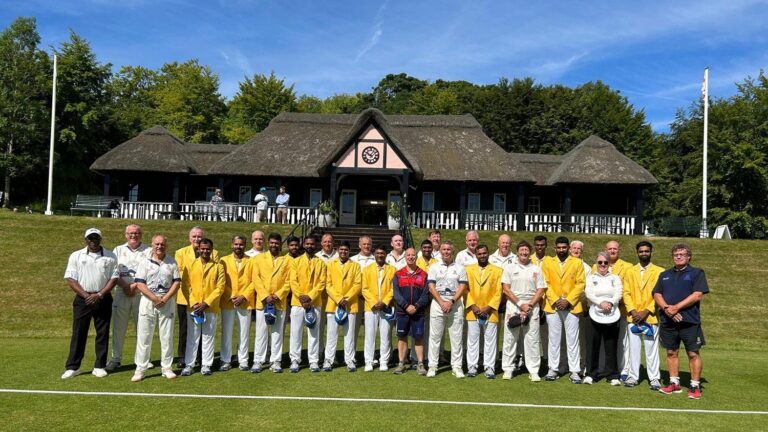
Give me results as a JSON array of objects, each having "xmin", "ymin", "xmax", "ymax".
[{"xmin": 464, "ymin": 263, "xmax": 504, "ymax": 322}]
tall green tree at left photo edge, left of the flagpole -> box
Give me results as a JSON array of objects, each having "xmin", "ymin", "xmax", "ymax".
[{"xmin": 0, "ymin": 18, "xmax": 50, "ymax": 207}]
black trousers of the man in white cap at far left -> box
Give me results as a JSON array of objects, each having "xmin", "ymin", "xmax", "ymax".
[{"xmin": 66, "ymin": 294, "xmax": 112, "ymax": 370}]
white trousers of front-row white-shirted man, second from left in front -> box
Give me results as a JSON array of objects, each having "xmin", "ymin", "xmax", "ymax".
[{"xmin": 133, "ymin": 295, "xmax": 176, "ymax": 371}]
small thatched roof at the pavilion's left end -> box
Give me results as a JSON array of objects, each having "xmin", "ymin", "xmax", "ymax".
[{"xmin": 91, "ymin": 126, "xmax": 200, "ymax": 173}]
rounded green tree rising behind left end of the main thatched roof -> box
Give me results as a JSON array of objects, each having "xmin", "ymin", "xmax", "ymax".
[{"xmin": 223, "ymin": 71, "xmax": 296, "ymax": 143}]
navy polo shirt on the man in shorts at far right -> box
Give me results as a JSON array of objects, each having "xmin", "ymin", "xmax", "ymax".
[{"xmin": 653, "ymin": 265, "xmax": 709, "ymax": 324}]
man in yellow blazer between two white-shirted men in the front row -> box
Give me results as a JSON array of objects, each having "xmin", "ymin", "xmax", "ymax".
[{"xmin": 464, "ymin": 245, "xmax": 504, "ymax": 379}]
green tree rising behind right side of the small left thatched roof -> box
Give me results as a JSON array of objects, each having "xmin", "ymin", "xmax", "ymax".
[{"xmin": 151, "ymin": 59, "xmax": 226, "ymax": 143}]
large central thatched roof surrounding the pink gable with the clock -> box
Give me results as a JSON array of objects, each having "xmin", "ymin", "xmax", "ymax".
[{"xmin": 209, "ymin": 109, "xmax": 532, "ymax": 182}]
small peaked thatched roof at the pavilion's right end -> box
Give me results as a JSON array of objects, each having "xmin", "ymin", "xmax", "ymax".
[{"xmin": 547, "ymin": 135, "xmax": 658, "ymax": 185}]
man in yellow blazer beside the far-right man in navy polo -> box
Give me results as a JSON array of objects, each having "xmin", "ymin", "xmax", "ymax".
[{"xmin": 623, "ymin": 240, "xmax": 664, "ymax": 390}]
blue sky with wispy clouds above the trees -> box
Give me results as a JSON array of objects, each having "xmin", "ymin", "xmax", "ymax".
[{"xmin": 0, "ymin": 0, "xmax": 768, "ymax": 131}]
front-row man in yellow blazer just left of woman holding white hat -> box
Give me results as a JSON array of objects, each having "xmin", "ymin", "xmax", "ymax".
[{"xmin": 541, "ymin": 237, "xmax": 585, "ymax": 384}]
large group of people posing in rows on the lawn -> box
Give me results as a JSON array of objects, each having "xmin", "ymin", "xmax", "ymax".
[{"xmin": 62, "ymin": 224, "xmax": 709, "ymax": 399}]
